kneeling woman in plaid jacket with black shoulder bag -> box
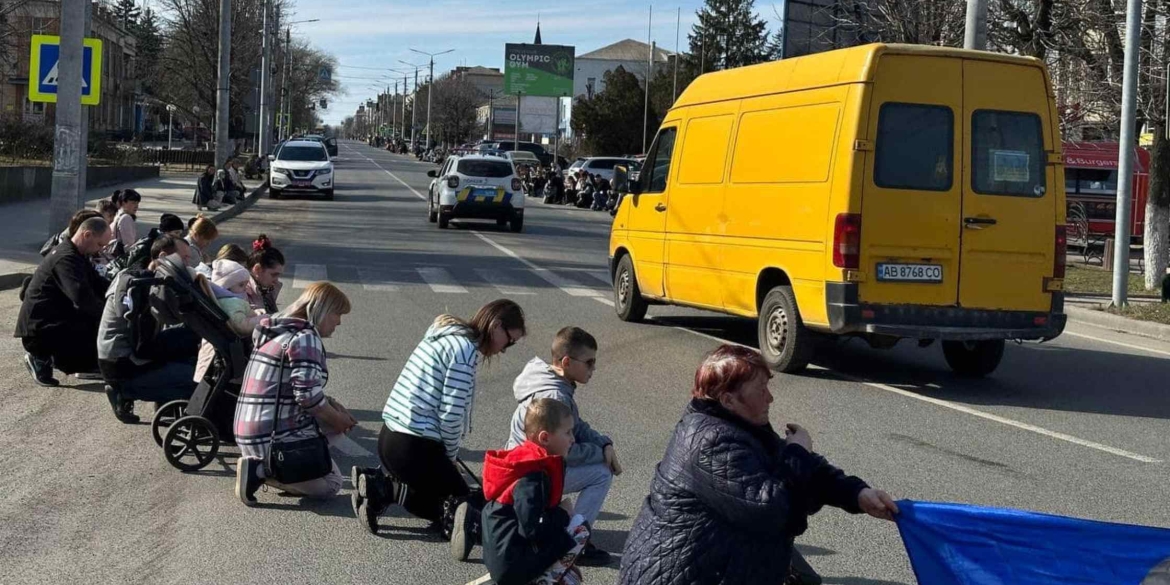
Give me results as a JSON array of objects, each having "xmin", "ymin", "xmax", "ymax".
[{"xmin": 235, "ymin": 282, "xmax": 358, "ymax": 505}]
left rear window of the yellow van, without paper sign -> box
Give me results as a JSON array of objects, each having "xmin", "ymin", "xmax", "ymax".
[{"xmin": 874, "ymin": 103, "xmax": 955, "ymax": 191}]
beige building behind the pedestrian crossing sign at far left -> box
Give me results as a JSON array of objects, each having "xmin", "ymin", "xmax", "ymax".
[{"xmin": 0, "ymin": 0, "xmax": 145, "ymax": 138}]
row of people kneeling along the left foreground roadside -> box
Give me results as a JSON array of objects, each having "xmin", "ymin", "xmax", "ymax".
[{"xmin": 16, "ymin": 182, "xmax": 899, "ymax": 585}]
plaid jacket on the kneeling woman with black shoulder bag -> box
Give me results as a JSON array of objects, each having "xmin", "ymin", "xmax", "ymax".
[{"xmin": 234, "ymin": 317, "xmax": 329, "ymax": 460}]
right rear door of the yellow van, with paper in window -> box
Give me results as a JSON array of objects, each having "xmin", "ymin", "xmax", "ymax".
[{"xmin": 959, "ymin": 60, "xmax": 1059, "ymax": 311}]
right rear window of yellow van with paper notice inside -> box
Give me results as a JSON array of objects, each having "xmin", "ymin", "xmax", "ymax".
[{"xmin": 971, "ymin": 110, "xmax": 1047, "ymax": 197}]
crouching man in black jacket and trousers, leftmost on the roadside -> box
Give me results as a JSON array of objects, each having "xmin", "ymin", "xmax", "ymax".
[{"xmin": 15, "ymin": 218, "xmax": 112, "ymax": 386}]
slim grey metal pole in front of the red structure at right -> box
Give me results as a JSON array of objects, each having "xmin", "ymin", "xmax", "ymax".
[{"xmin": 1113, "ymin": 0, "xmax": 1142, "ymax": 308}]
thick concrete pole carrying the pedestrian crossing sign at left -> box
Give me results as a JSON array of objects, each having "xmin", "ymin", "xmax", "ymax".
[{"xmin": 48, "ymin": 0, "xmax": 89, "ymax": 234}]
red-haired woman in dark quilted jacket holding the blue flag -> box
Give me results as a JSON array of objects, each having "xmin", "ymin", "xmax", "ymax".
[{"xmin": 620, "ymin": 345, "xmax": 897, "ymax": 585}]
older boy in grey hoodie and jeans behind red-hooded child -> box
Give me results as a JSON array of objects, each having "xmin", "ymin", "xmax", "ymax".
[{"xmin": 508, "ymin": 326, "xmax": 621, "ymax": 566}]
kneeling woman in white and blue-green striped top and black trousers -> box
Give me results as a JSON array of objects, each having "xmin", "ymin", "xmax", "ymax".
[{"xmin": 351, "ymin": 300, "xmax": 527, "ymax": 536}]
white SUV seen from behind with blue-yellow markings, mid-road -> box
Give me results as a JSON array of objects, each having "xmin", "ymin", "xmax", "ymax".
[{"xmin": 427, "ymin": 154, "xmax": 524, "ymax": 232}]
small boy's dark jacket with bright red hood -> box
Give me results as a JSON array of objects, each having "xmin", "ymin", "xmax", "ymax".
[{"xmin": 483, "ymin": 441, "xmax": 576, "ymax": 585}]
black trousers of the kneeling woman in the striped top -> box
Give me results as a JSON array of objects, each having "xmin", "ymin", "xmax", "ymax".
[{"xmin": 378, "ymin": 425, "xmax": 470, "ymax": 522}]
